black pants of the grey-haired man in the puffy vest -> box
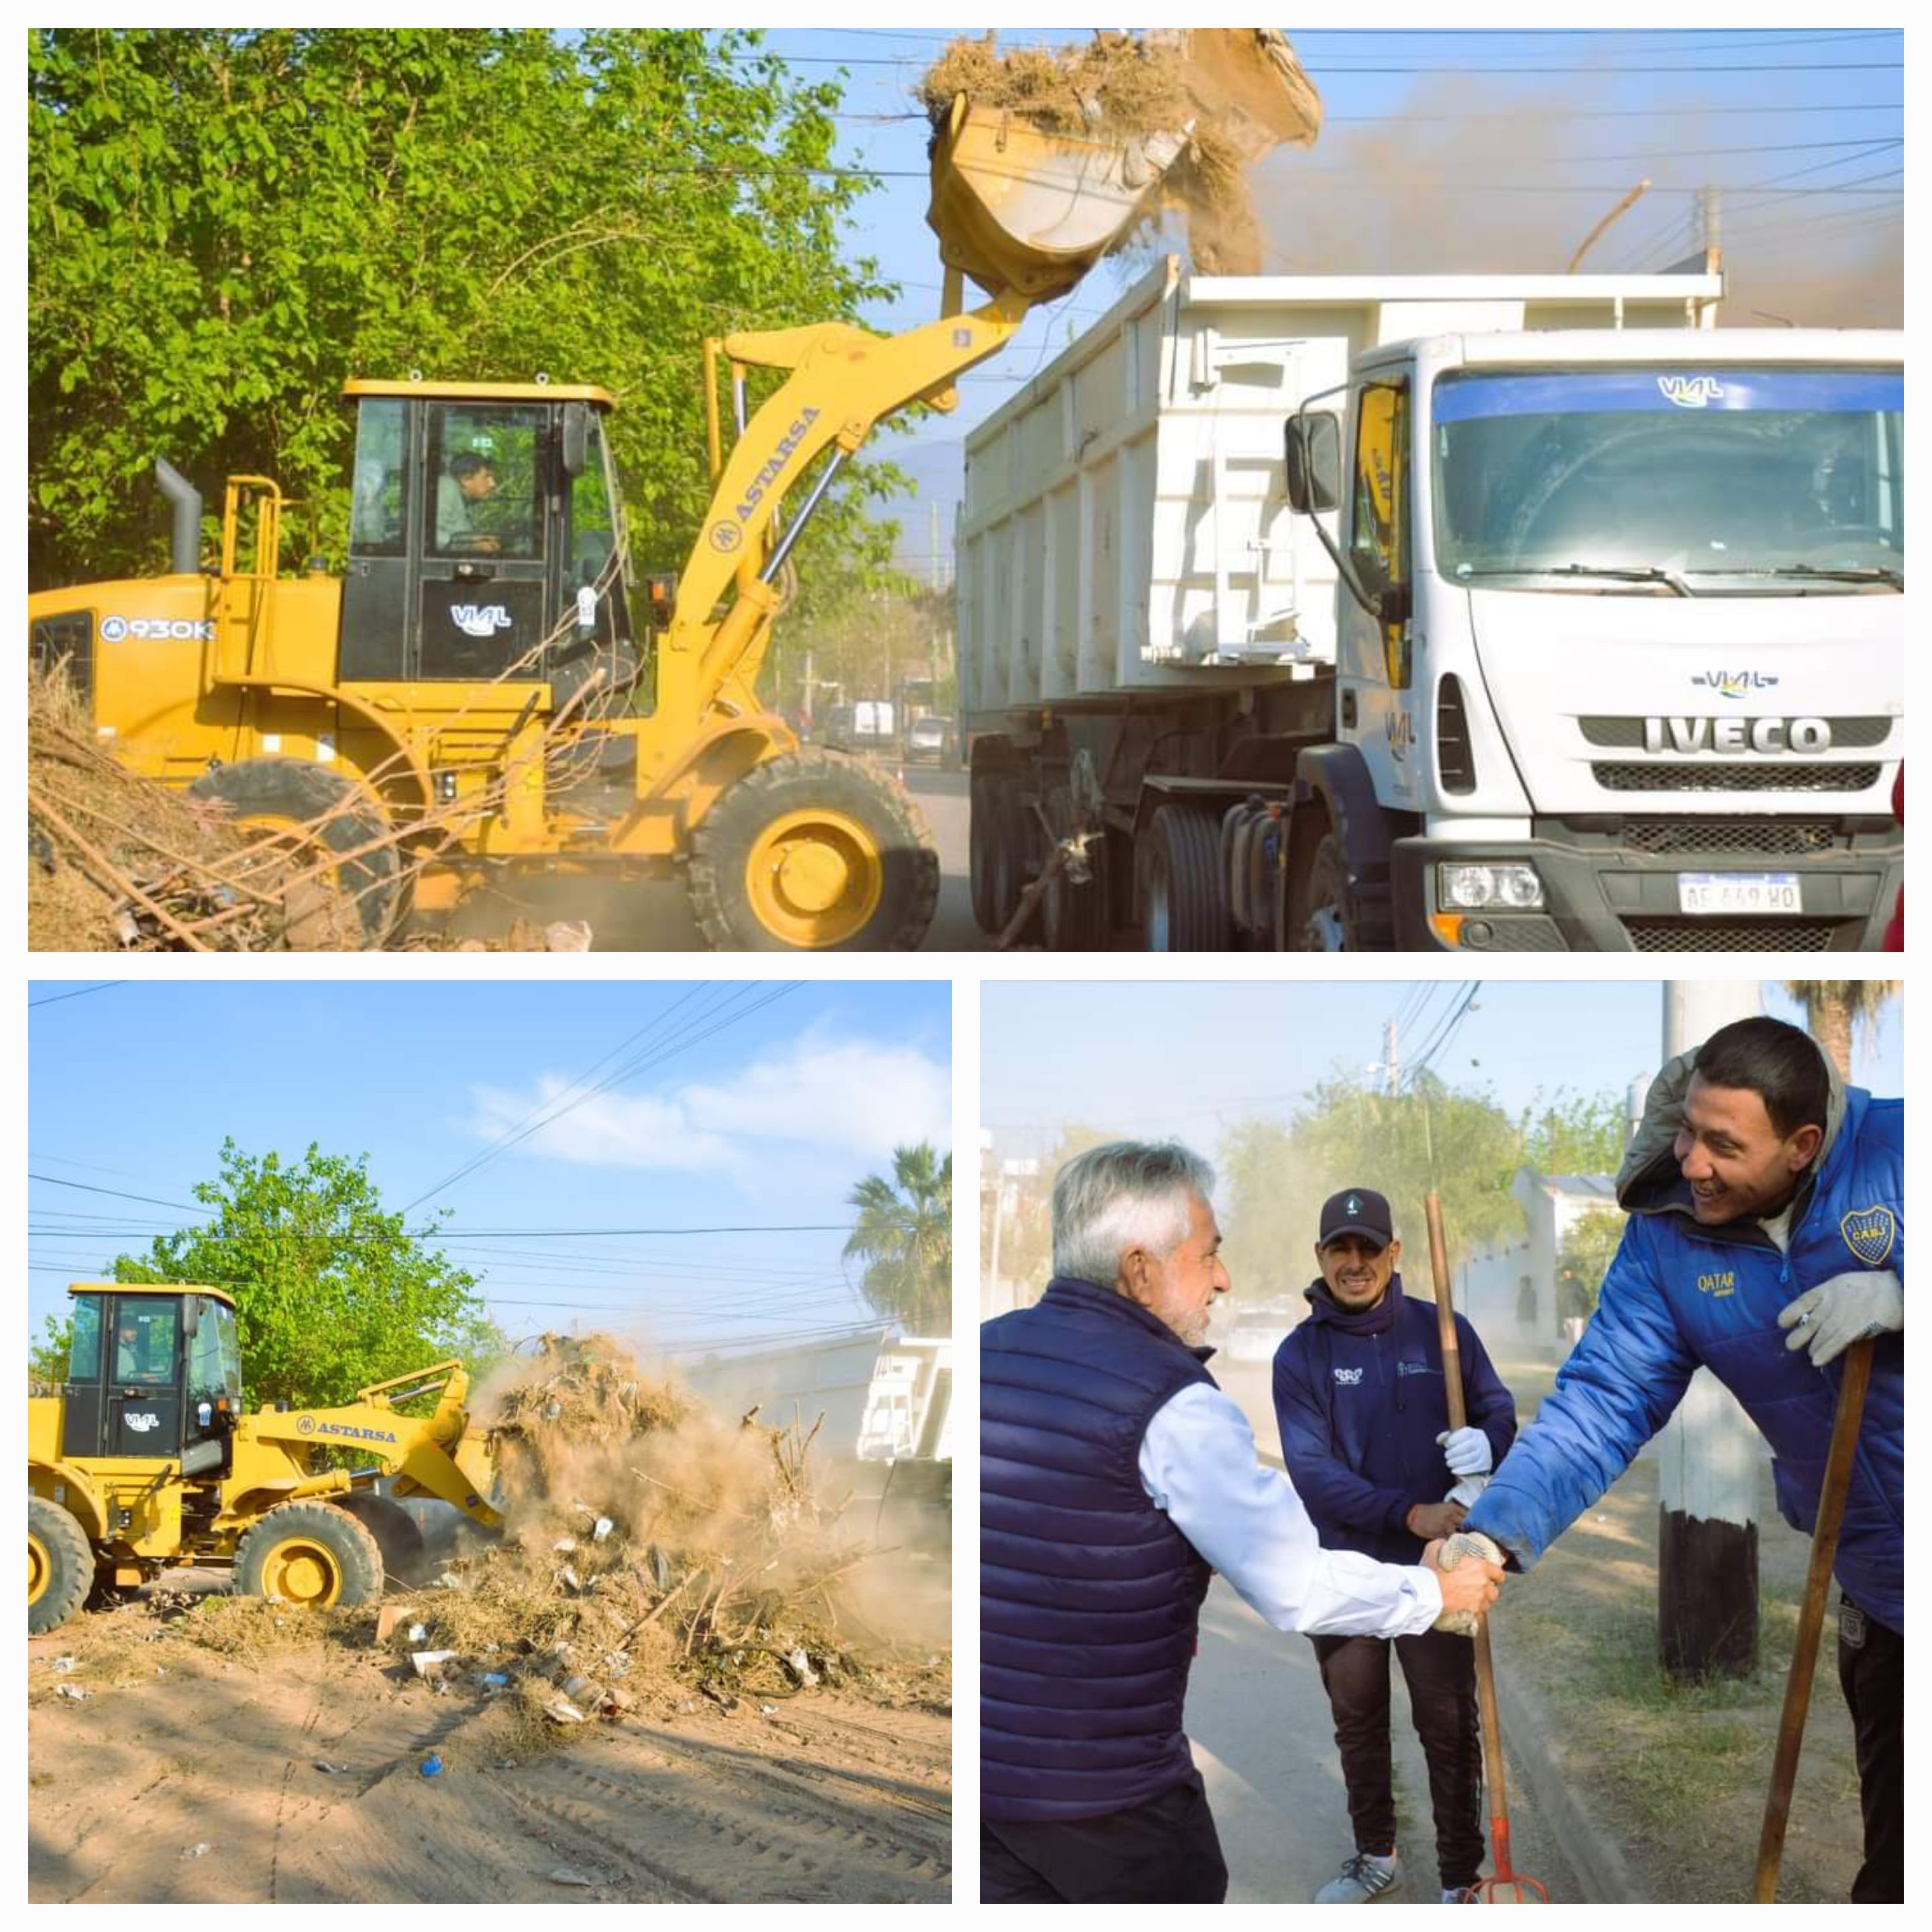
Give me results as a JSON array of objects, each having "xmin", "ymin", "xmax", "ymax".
[{"xmin": 979, "ymin": 1772, "xmax": 1227, "ymax": 1905}]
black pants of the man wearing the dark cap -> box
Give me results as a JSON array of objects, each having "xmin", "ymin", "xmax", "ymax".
[{"xmin": 1310, "ymin": 1631, "xmax": 1484, "ymax": 1890}]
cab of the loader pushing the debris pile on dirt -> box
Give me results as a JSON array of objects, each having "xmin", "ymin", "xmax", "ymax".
[{"xmin": 60, "ymin": 1283, "xmax": 241, "ymax": 1476}]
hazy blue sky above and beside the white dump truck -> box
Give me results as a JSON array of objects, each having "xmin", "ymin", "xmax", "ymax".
[{"xmin": 738, "ymin": 25, "xmax": 1905, "ymax": 574}]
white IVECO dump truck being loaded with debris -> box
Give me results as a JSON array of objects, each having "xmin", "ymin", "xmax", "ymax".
[{"xmin": 958, "ymin": 261, "xmax": 1905, "ymax": 953}]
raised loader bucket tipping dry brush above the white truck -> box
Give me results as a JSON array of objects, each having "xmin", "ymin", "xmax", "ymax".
[{"xmin": 926, "ymin": 95, "xmax": 1188, "ymax": 301}]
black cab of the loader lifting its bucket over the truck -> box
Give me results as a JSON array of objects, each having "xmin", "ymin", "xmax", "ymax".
[{"xmin": 338, "ymin": 382, "xmax": 637, "ymax": 705}]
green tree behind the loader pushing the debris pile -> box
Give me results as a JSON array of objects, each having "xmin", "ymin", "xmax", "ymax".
[{"xmin": 112, "ymin": 1140, "xmax": 506, "ymax": 1407}]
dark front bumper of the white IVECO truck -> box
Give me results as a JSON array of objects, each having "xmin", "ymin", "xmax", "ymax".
[{"xmin": 1391, "ymin": 819, "xmax": 1905, "ymax": 953}]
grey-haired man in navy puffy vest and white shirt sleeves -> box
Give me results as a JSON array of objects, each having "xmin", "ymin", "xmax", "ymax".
[{"xmin": 979, "ymin": 1142, "xmax": 1501, "ymax": 1905}]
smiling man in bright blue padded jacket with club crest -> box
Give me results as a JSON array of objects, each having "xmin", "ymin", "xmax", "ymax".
[{"xmin": 1466, "ymin": 1018, "xmax": 1905, "ymax": 1905}]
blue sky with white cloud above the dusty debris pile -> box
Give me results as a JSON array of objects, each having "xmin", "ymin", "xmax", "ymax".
[{"xmin": 27, "ymin": 979, "xmax": 953, "ymax": 1346}]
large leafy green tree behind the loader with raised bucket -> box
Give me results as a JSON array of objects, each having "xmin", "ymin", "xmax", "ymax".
[{"xmin": 27, "ymin": 27, "xmax": 893, "ymax": 641}]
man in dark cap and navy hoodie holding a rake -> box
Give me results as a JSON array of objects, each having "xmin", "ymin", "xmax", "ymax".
[{"xmin": 1275, "ymin": 1188, "xmax": 1517, "ymax": 1905}]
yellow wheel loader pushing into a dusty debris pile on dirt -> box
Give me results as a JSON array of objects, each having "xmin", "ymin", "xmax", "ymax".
[{"xmin": 27, "ymin": 1283, "xmax": 502, "ymax": 1633}]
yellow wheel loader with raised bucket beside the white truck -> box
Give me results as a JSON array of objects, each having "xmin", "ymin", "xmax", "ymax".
[{"xmin": 29, "ymin": 29, "xmax": 1313, "ymax": 949}]
